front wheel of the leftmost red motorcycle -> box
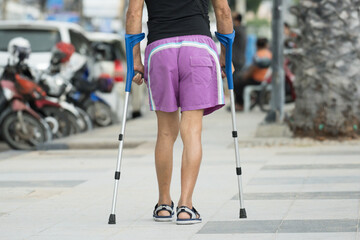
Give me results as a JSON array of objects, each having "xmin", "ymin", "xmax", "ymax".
[{"xmin": 1, "ymin": 113, "xmax": 51, "ymax": 150}]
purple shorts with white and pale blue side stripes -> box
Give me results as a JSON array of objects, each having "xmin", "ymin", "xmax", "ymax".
[{"xmin": 144, "ymin": 35, "xmax": 225, "ymax": 115}]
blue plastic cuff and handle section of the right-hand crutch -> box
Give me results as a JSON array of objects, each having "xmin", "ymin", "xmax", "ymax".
[{"xmin": 215, "ymin": 31, "xmax": 235, "ymax": 90}]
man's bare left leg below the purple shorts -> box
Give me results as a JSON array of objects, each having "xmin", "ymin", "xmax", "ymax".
[{"xmin": 155, "ymin": 111, "xmax": 179, "ymax": 216}]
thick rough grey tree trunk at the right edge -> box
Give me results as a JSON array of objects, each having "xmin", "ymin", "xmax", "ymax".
[{"xmin": 291, "ymin": 0, "xmax": 360, "ymax": 138}]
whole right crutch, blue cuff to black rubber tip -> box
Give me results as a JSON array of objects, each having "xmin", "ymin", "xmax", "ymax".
[{"xmin": 215, "ymin": 31, "xmax": 246, "ymax": 218}]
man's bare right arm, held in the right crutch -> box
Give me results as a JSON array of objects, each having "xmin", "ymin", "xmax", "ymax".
[{"xmin": 211, "ymin": 0, "xmax": 234, "ymax": 77}]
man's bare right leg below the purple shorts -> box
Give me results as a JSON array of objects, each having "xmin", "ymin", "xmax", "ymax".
[{"xmin": 178, "ymin": 110, "xmax": 204, "ymax": 219}]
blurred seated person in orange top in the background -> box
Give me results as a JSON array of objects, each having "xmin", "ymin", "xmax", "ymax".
[{"xmin": 234, "ymin": 38, "xmax": 272, "ymax": 111}]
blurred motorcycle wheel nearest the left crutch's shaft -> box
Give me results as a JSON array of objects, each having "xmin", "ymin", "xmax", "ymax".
[{"xmin": 86, "ymin": 102, "xmax": 112, "ymax": 127}]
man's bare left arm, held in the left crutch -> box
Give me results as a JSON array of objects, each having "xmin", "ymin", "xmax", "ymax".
[{"xmin": 126, "ymin": 0, "xmax": 144, "ymax": 85}]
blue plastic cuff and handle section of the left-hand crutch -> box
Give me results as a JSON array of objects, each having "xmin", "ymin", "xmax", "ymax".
[{"xmin": 125, "ymin": 33, "xmax": 145, "ymax": 92}]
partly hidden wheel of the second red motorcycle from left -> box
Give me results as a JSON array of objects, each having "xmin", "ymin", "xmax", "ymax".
[{"xmin": 43, "ymin": 107, "xmax": 71, "ymax": 138}]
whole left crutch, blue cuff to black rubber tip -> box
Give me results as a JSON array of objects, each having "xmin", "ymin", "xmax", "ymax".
[{"xmin": 109, "ymin": 33, "xmax": 145, "ymax": 224}]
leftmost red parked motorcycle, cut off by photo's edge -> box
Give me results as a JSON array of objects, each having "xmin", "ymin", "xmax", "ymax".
[{"xmin": 0, "ymin": 77, "xmax": 52, "ymax": 150}]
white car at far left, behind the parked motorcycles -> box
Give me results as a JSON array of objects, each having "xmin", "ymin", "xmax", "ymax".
[{"xmin": 0, "ymin": 21, "xmax": 90, "ymax": 70}]
